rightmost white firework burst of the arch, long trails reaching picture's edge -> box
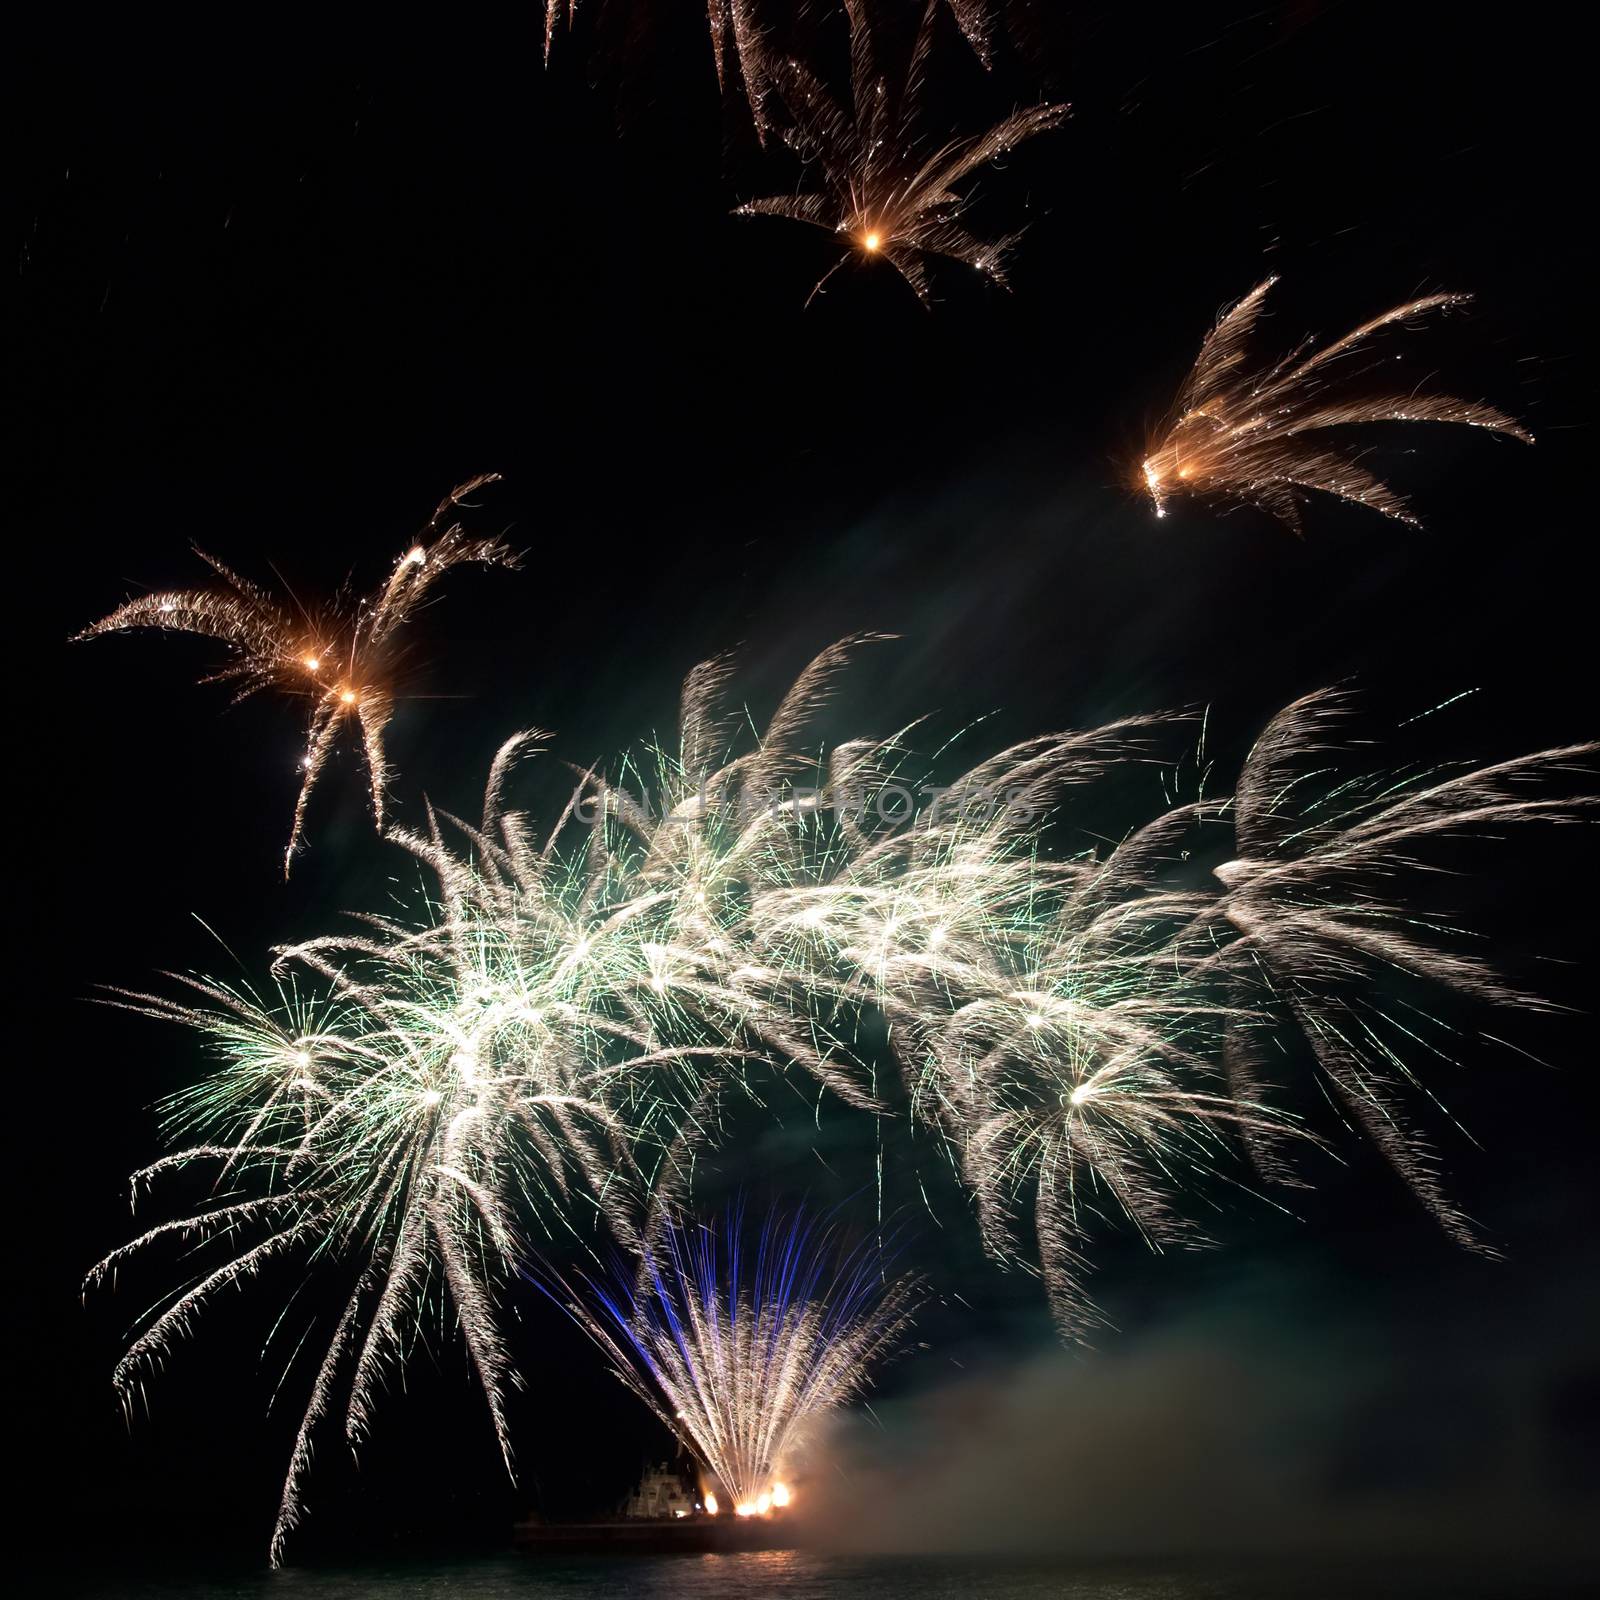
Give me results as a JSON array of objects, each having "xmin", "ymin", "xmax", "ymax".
[{"xmin": 1195, "ymin": 690, "xmax": 1600, "ymax": 1250}]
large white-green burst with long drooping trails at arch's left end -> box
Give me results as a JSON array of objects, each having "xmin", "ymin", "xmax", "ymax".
[{"xmin": 91, "ymin": 812, "xmax": 662, "ymax": 1558}]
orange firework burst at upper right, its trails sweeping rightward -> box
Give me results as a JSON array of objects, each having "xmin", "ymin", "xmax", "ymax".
[{"xmin": 1142, "ymin": 278, "xmax": 1533, "ymax": 533}]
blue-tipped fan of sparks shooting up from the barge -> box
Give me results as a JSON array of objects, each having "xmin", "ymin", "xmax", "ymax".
[{"xmin": 536, "ymin": 1210, "xmax": 917, "ymax": 1517}]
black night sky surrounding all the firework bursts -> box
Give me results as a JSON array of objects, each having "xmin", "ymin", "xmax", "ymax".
[{"xmin": 6, "ymin": 0, "xmax": 1600, "ymax": 1587}]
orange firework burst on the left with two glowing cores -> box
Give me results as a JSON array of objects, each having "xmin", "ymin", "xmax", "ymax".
[{"xmin": 75, "ymin": 472, "xmax": 517, "ymax": 875}]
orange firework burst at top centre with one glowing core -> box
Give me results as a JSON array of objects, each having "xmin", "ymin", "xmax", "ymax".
[{"xmin": 736, "ymin": 0, "xmax": 1067, "ymax": 304}]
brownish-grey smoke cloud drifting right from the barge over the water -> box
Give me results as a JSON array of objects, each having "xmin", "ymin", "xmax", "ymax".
[{"xmin": 793, "ymin": 1260, "xmax": 1600, "ymax": 1560}]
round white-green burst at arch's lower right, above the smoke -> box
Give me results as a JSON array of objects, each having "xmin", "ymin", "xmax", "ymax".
[{"xmin": 920, "ymin": 819, "xmax": 1293, "ymax": 1338}]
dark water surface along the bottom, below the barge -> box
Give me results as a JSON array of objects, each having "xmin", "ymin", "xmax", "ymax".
[{"xmin": 65, "ymin": 1550, "xmax": 1586, "ymax": 1600}]
